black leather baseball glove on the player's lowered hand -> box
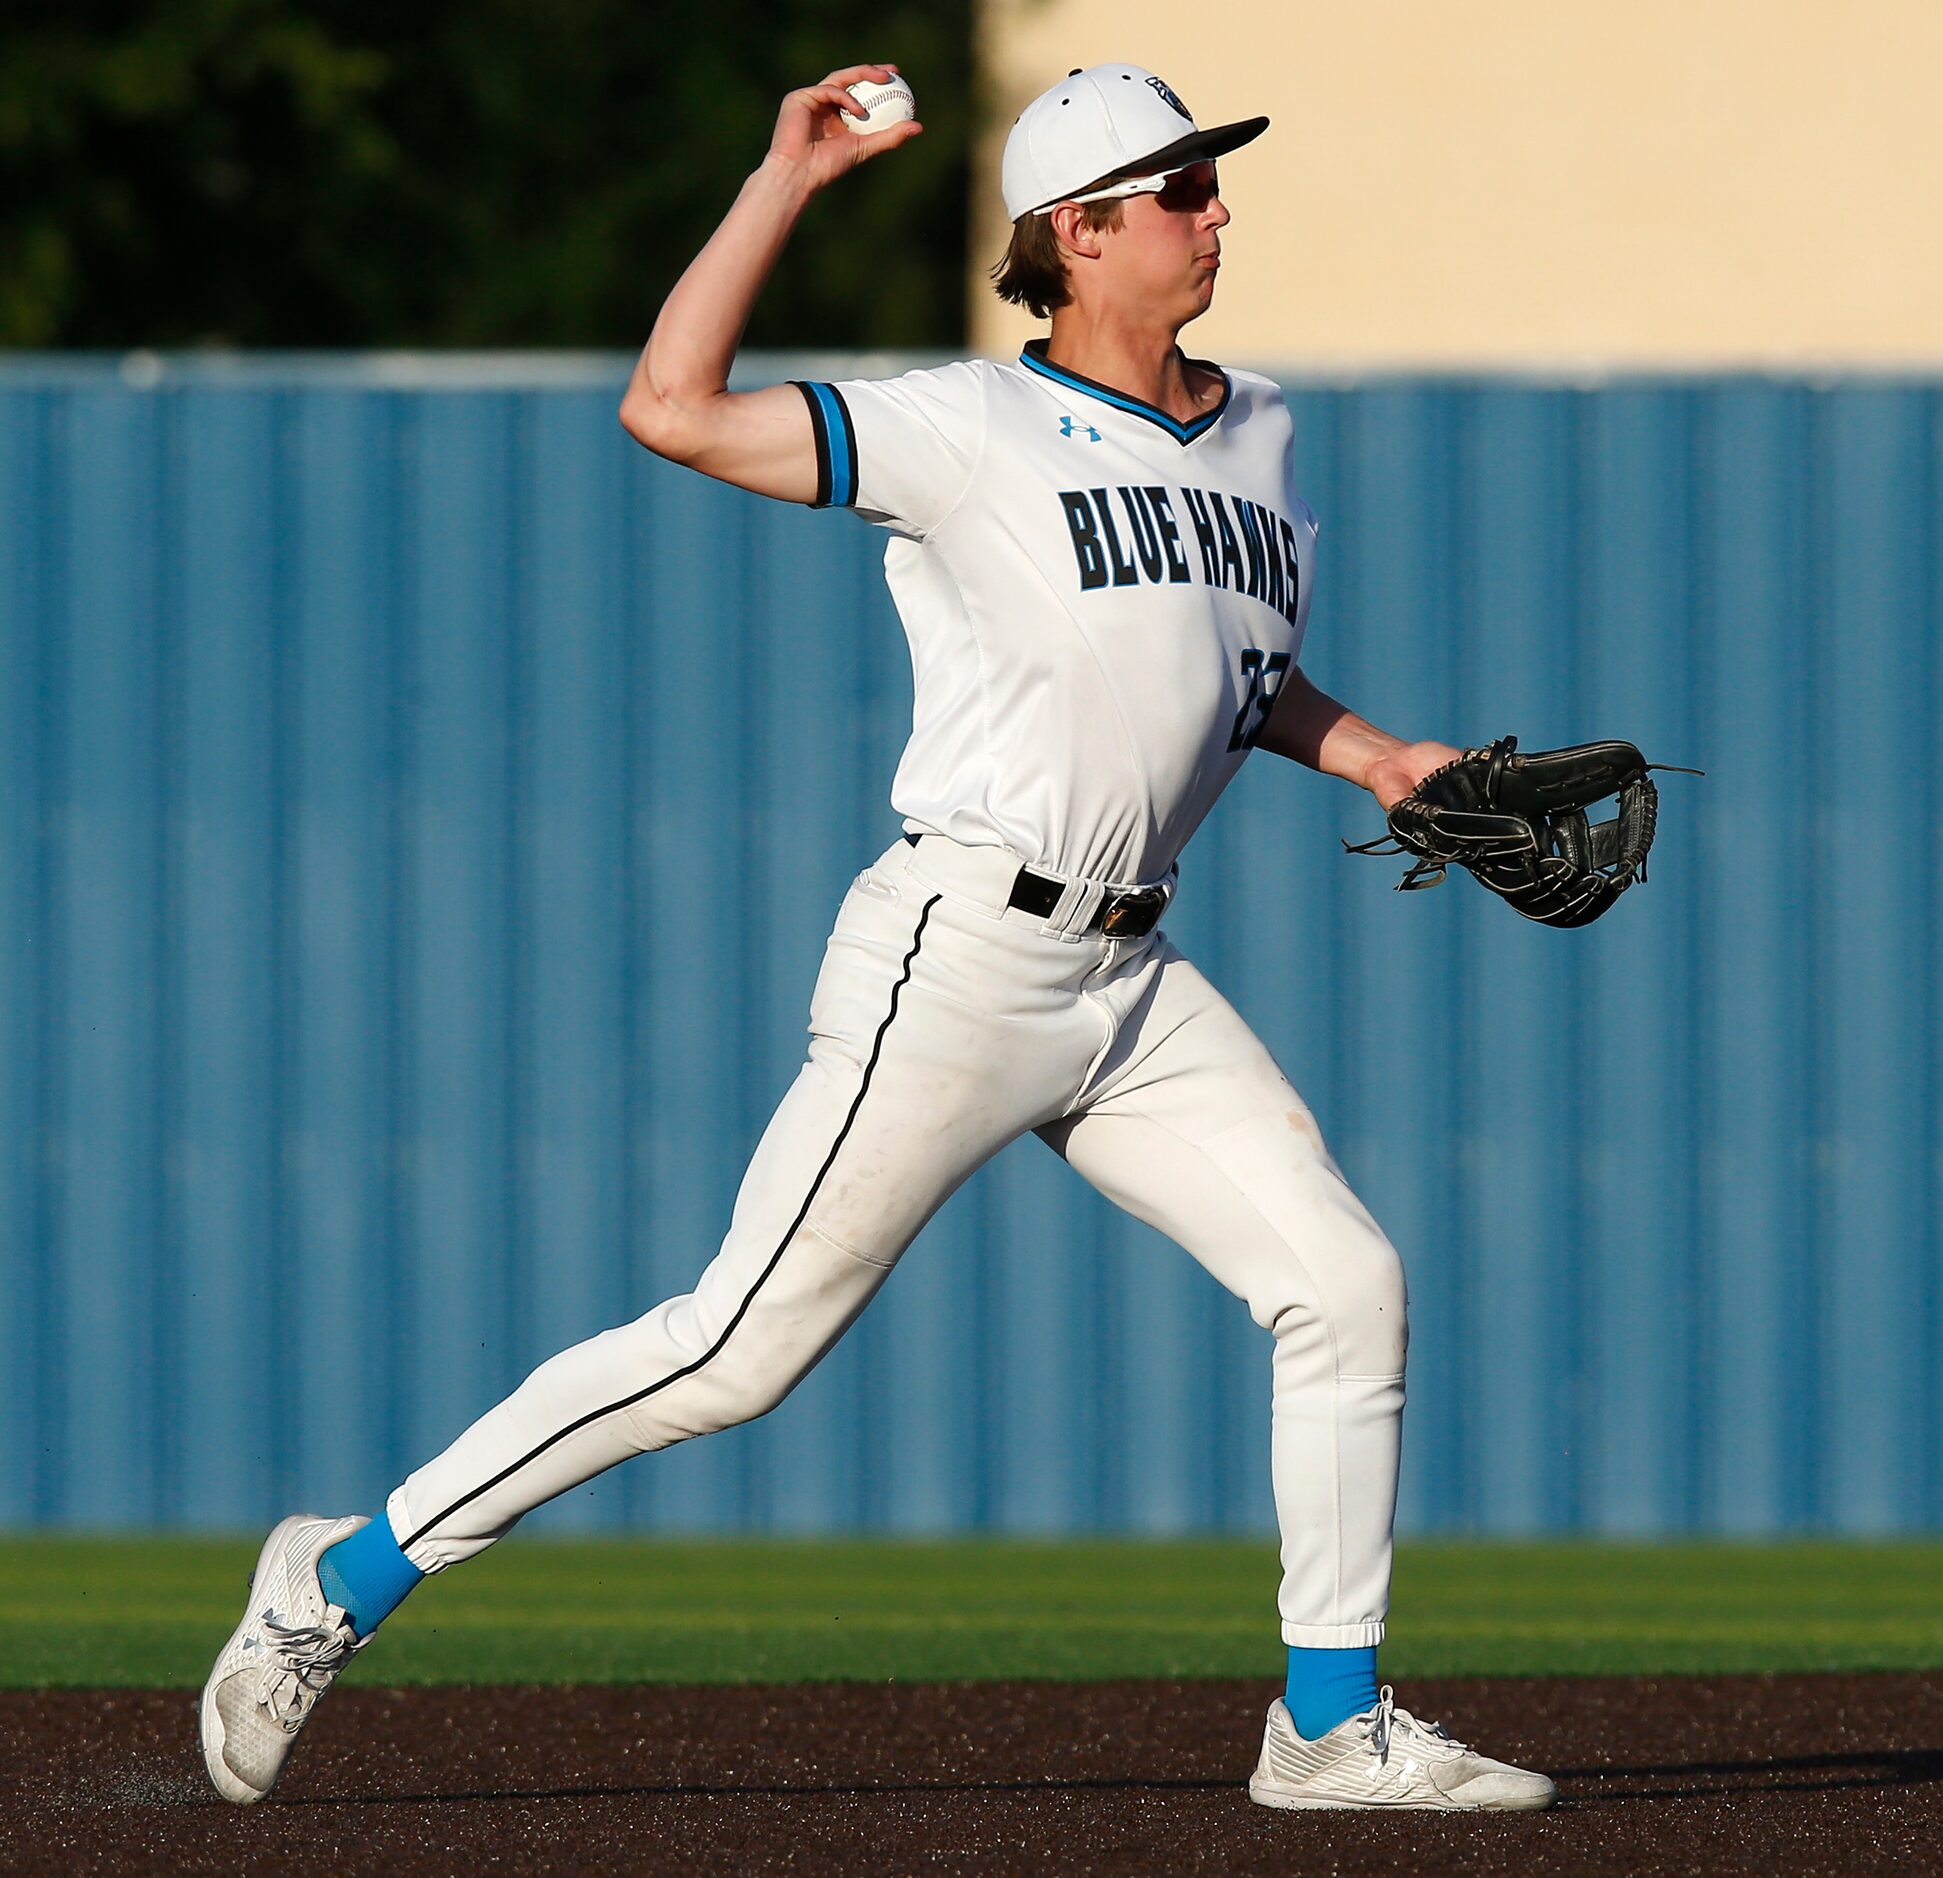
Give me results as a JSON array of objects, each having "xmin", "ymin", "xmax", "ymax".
[{"xmin": 1343, "ymin": 736, "xmax": 1700, "ymax": 926}]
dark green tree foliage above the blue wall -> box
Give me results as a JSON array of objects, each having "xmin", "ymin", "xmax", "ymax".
[{"xmin": 0, "ymin": 0, "xmax": 972, "ymax": 348}]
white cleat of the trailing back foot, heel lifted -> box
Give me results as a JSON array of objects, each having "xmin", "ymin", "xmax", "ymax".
[{"xmin": 202, "ymin": 1513, "xmax": 369, "ymax": 1806}]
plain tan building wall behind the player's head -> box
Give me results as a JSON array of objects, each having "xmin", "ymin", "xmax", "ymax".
[{"xmin": 979, "ymin": 0, "xmax": 1943, "ymax": 369}]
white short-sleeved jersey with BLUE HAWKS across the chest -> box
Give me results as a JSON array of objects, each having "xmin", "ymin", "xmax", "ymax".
[{"xmin": 801, "ymin": 340, "xmax": 1315, "ymax": 884}]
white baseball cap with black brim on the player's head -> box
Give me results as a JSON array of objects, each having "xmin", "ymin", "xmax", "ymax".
[{"xmin": 999, "ymin": 66, "xmax": 1269, "ymax": 221}]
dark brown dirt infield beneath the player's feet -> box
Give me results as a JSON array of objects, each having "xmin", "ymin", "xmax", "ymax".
[{"xmin": 0, "ymin": 1674, "xmax": 1943, "ymax": 1878}]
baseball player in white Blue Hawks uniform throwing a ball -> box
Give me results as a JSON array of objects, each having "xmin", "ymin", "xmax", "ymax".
[{"xmin": 202, "ymin": 64, "xmax": 1552, "ymax": 1810}]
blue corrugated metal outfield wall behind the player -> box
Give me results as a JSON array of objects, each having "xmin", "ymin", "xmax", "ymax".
[{"xmin": 0, "ymin": 361, "xmax": 1943, "ymax": 1532}]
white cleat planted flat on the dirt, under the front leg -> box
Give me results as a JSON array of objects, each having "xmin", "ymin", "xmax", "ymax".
[{"xmin": 1247, "ymin": 1684, "xmax": 1558, "ymax": 1812}]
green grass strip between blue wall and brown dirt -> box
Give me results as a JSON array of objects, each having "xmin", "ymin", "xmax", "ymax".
[{"xmin": 0, "ymin": 1536, "xmax": 1943, "ymax": 1688}]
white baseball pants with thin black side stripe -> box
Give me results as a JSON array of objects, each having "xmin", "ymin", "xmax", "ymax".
[{"xmin": 389, "ymin": 835, "xmax": 1407, "ymax": 1647}]
